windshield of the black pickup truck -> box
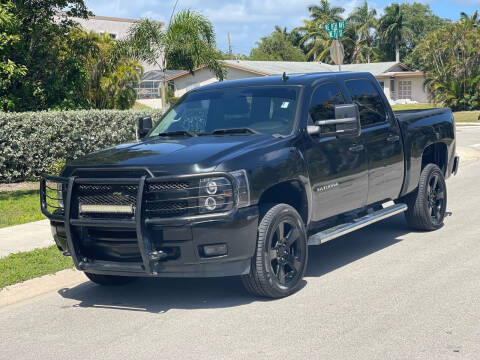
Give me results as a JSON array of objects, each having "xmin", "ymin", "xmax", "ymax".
[{"xmin": 150, "ymin": 86, "xmax": 299, "ymax": 136}]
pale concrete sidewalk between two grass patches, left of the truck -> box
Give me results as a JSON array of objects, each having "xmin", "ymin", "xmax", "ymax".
[{"xmin": 0, "ymin": 220, "xmax": 55, "ymax": 258}]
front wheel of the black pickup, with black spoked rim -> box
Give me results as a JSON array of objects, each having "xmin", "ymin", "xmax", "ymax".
[{"xmin": 242, "ymin": 204, "xmax": 308, "ymax": 298}]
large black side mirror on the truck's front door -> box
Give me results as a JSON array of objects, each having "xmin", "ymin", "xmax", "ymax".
[{"xmin": 307, "ymin": 104, "xmax": 361, "ymax": 137}]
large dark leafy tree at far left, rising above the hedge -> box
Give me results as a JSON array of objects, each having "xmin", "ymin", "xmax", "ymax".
[{"xmin": 0, "ymin": 0, "xmax": 90, "ymax": 111}]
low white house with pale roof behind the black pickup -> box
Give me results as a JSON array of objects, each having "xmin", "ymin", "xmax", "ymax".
[{"xmin": 167, "ymin": 60, "xmax": 429, "ymax": 103}]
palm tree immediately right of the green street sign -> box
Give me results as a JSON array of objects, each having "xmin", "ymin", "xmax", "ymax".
[{"xmin": 348, "ymin": 0, "xmax": 378, "ymax": 63}]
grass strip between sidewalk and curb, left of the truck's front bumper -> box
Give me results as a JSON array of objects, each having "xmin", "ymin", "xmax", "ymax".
[{"xmin": 0, "ymin": 246, "xmax": 73, "ymax": 289}]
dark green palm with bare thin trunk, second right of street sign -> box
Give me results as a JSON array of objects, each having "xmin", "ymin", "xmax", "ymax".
[{"xmin": 378, "ymin": 4, "xmax": 411, "ymax": 62}]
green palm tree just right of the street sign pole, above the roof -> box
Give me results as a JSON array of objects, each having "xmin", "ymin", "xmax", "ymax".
[{"xmin": 347, "ymin": 0, "xmax": 378, "ymax": 63}]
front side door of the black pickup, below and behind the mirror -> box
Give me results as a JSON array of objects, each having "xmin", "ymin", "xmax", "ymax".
[{"xmin": 305, "ymin": 82, "xmax": 368, "ymax": 221}]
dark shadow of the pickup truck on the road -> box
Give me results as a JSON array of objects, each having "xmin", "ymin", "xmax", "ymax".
[{"xmin": 58, "ymin": 215, "xmax": 408, "ymax": 313}]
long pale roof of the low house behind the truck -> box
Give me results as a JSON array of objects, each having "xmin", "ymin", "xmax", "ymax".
[{"xmin": 167, "ymin": 60, "xmax": 417, "ymax": 80}]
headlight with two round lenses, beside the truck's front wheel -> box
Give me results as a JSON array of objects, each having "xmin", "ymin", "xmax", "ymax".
[{"xmin": 199, "ymin": 170, "xmax": 250, "ymax": 214}]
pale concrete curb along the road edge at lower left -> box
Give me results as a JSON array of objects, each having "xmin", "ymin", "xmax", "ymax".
[{"xmin": 0, "ymin": 269, "xmax": 87, "ymax": 309}]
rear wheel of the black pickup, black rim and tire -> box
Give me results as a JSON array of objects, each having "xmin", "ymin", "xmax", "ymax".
[{"xmin": 404, "ymin": 164, "xmax": 447, "ymax": 231}]
